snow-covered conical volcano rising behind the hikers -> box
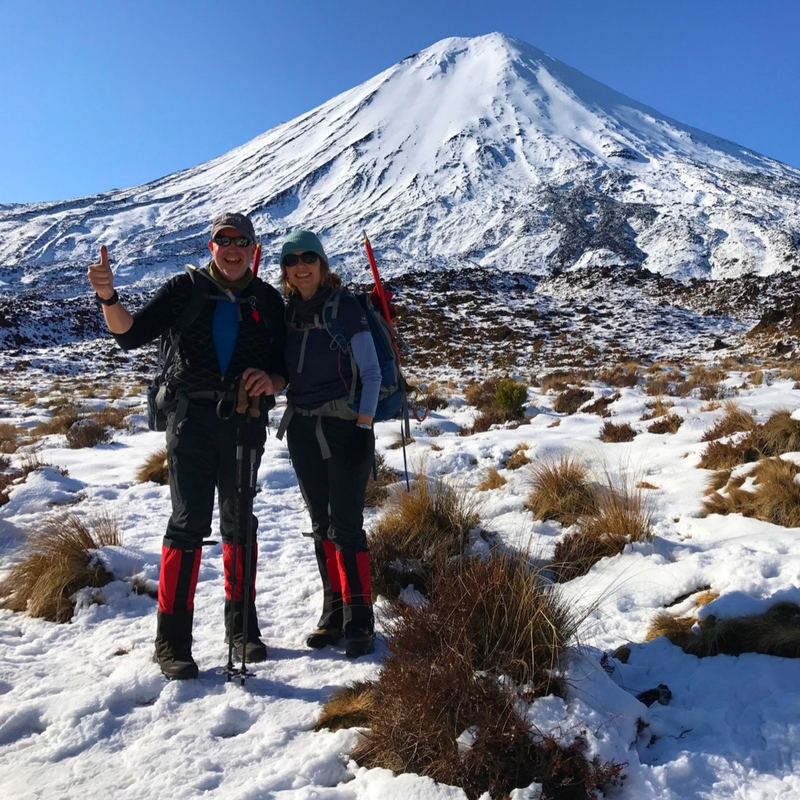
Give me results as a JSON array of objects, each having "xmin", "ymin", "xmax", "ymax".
[{"xmin": 0, "ymin": 33, "xmax": 800, "ymax": 296}]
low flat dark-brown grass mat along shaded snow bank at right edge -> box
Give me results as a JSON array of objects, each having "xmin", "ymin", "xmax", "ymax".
[{"xmin": 647, "ymin": 602, "xmax": 800, "ymax": 658}]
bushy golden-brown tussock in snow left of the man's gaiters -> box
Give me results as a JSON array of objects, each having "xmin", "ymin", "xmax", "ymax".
[{"xmin": 0, "ymin": 514, "xmax": 122, "ymax": 622}]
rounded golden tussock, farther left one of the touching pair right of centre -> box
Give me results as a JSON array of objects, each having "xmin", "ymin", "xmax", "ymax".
[{"xmin": 525, "ymin": 454, "xmax": 597, "ymax": 525}]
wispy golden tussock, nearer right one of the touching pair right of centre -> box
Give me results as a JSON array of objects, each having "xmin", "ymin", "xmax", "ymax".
[{"xmin": 550, "ymin": 478, "xmax": 653, "ymax": 582}]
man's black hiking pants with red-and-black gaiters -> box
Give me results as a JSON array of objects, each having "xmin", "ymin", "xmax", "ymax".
[{"xmin": 156, "ymin": 400, "xmax": 266, "ymax": 654}]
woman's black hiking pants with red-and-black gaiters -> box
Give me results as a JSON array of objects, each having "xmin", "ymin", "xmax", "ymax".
[{"xmin": 286, "ymin": 413, "xmax": 374, "ymax": 638}]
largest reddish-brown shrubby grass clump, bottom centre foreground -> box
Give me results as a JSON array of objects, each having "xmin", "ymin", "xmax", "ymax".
[{"xmin": 334, "ymin": 555, "xmax": 622, "ymax": 800}]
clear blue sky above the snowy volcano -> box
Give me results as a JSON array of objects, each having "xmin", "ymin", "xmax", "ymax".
[{"xmin": 0, "ymin": 0, "xmax": 800, "ymax": 203}]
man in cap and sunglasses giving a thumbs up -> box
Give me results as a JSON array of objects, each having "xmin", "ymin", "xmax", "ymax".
[{"xmin": 88, "ymin": 212, "xmax": 287, "ymax": 680}]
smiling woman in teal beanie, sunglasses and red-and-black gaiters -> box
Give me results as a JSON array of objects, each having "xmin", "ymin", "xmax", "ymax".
[{"xmin": 278, "ymin": 230, "xmax": 381, "ymax": 658}]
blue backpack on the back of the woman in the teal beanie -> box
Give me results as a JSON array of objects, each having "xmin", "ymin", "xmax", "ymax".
[{"xmin": 289, "ymin": 289, "xmax": 409, "ymax": 428}]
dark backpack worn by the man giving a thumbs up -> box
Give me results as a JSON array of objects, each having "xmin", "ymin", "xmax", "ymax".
[{"xmin": 146, "ymin": 264, "xmax": 275, "ymax": 431}]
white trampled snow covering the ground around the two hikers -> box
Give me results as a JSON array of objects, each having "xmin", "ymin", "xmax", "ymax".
[{"xmin": 0, "ymin": 374, "xmax": 800, "ymax": 800}]
